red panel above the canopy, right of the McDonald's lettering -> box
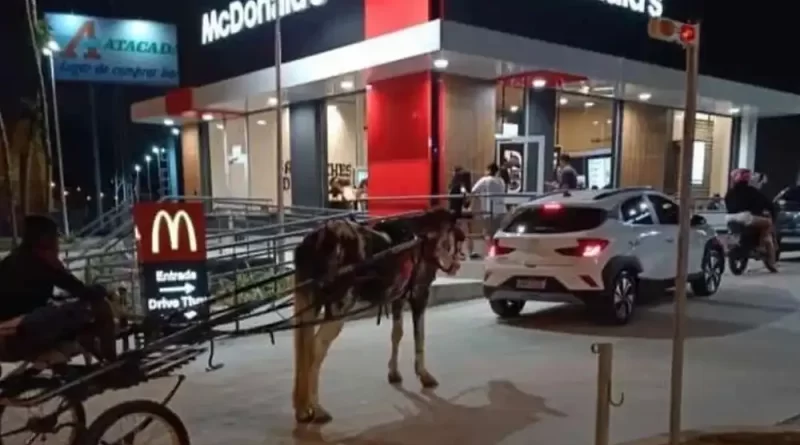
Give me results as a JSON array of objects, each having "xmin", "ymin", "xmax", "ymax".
[{"xmin": 364, "ymin": 0, "xmax": 430, "ymax": 39}]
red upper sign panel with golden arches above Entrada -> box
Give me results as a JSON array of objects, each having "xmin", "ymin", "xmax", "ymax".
[{"xmin": 133, "ymin": 202, "xmax": 206, "ymax": 263}]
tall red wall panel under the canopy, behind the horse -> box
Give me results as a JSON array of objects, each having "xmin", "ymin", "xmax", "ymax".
[{"xmin": 367, "ymin": 72, "xmax": 432, "ymax": 215}]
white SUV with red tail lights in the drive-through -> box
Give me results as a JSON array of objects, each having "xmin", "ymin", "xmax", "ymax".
[{"xmin": 483, "ymin": 188, "xmax": 725, "ymax": 324}]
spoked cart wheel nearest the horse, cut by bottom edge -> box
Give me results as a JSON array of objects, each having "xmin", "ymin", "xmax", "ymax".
[{"xmin": 84, "ymin": 400, "xmax": 190, "ymax": 445}]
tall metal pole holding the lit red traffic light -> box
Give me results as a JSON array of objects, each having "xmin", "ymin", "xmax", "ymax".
[{"xmin": 669, "ymin": 25, "xmax": 700, "ymax": 445}]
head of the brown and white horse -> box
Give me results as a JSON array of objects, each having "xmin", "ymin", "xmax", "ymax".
[{"xmin": 417, "ymin": 208, "xmax": 466, "ymax": 275}]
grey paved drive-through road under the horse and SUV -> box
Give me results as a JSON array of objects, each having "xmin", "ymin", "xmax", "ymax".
[{"xmin": 76, "ymin": 256, "xmax": 800, "ymax": 445}]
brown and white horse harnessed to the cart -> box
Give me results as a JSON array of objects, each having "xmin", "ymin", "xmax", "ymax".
[{"xmin": 293, "ymin": 208, "xmax": 465, "ymax": 423}]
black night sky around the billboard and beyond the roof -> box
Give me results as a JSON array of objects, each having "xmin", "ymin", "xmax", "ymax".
[{"xmin": 0, "ymin": 0, "xmax": 800, "ymax": 198}]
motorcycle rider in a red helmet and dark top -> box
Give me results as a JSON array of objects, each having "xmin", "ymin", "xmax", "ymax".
[{"xmin": 725, "ymin": 168, "xmax": 778, "ymax": 272}]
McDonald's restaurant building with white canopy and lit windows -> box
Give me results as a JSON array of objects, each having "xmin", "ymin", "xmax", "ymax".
[{"xmin": 131, "ymin": 0, "xmax": 800, "ymax": 210}]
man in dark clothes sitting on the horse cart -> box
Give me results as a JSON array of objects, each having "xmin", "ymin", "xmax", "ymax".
[{"xmin": 0, "ymin": 216, "xmax": 116, "ymax": 361}]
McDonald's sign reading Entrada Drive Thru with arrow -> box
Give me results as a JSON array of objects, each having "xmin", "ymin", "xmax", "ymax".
[{"xmin": 133, "ymin": 202, "xmax": 208, "ymax": 312}]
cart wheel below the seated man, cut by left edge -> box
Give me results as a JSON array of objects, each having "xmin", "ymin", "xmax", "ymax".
[{"xmin": 0, "ymin": 378, "xmax": 86, "ymax": 445}]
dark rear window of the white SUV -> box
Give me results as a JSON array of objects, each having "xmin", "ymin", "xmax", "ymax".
[{"xmin": 503, "ymin": 203, "xmax": 608, "ymax": 234}]
